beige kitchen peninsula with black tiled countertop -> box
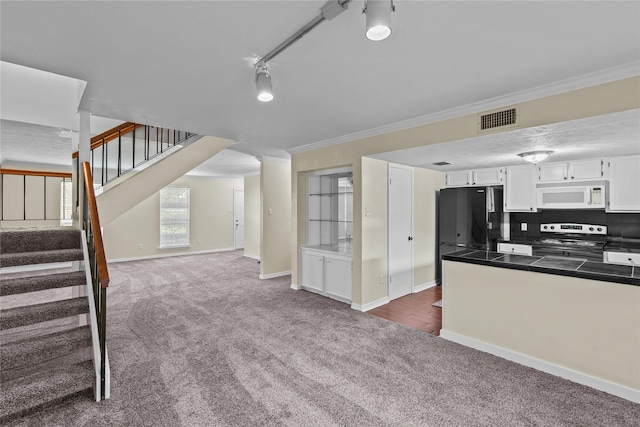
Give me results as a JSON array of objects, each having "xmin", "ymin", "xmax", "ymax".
[{"xmin": 441, "ymin": 249, "xmax": 640, "ymax": 403}]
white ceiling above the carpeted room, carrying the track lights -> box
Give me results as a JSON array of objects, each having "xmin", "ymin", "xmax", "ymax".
[{"xmin": 0, "ymin": 0, "xmax": 640, "ymax": 175}]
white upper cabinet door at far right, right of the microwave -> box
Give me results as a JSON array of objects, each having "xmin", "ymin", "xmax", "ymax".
[{"xmin": 607, "ymin": 155, "xmax": 640, "ymax": 212}]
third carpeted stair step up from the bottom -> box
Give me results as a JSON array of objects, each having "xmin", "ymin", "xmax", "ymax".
[{"xmin": 0, "ymin": 297, "xmax": 89, "ymax": 330}]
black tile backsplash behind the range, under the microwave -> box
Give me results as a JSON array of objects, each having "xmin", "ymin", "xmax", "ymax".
[{"xmin": 510, "ymin": 209, "xmax": 640, "ymax": 239}]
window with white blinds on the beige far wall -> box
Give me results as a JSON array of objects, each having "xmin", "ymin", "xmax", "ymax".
[{"xmin": 160, "ymin": 187, "xmax": 189, "ymax": 248}]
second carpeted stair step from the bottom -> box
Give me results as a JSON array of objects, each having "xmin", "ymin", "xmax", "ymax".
[{"xmin": 0, "ymin": 326, "xmax": 91, "ymax": 374}]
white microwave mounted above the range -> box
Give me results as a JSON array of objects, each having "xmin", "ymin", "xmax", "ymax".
[{"xmin": 536, "ymin": 183, "xmax": 607, "ymax": 209}]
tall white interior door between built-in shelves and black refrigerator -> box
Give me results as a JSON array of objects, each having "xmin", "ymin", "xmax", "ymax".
[{"xmin": 389, "ymin": 165, "xmax": 413, "ymax": 300}]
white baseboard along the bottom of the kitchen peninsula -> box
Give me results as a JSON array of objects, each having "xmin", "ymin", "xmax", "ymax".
[{"xmin": 440, "ymin": 329, "xmax": 640, "ymax": 403}]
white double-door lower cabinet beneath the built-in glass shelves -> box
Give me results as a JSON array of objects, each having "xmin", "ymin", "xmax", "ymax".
[{"xmin": 300, "ymin": 248, "xmax": 353, "ymax": 303}]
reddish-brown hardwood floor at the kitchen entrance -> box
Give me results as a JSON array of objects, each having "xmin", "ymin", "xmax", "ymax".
[{"xmin": 368, "ymin": 286, "xmax": 442, "ymax": 336}]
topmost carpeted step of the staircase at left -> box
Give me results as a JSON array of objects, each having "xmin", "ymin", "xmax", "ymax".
[{"xmin": 0, "ymin": 227, "xmax": 82, "ymax": 254}]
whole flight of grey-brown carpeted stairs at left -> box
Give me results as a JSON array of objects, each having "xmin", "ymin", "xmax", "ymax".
[{"xmin": 0, "ymin": 227, "xmax": 95, "ymax": 424}]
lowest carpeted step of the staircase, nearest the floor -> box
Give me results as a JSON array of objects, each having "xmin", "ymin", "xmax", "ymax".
[{"xmin": 0, "ymin": 361, "xmax": 95, "ymax": 424}]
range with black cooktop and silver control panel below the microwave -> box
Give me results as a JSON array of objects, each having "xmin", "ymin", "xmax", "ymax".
[{"xmin": 532, "ymin": 223, "xmax": 607, "ymax": 262}]
